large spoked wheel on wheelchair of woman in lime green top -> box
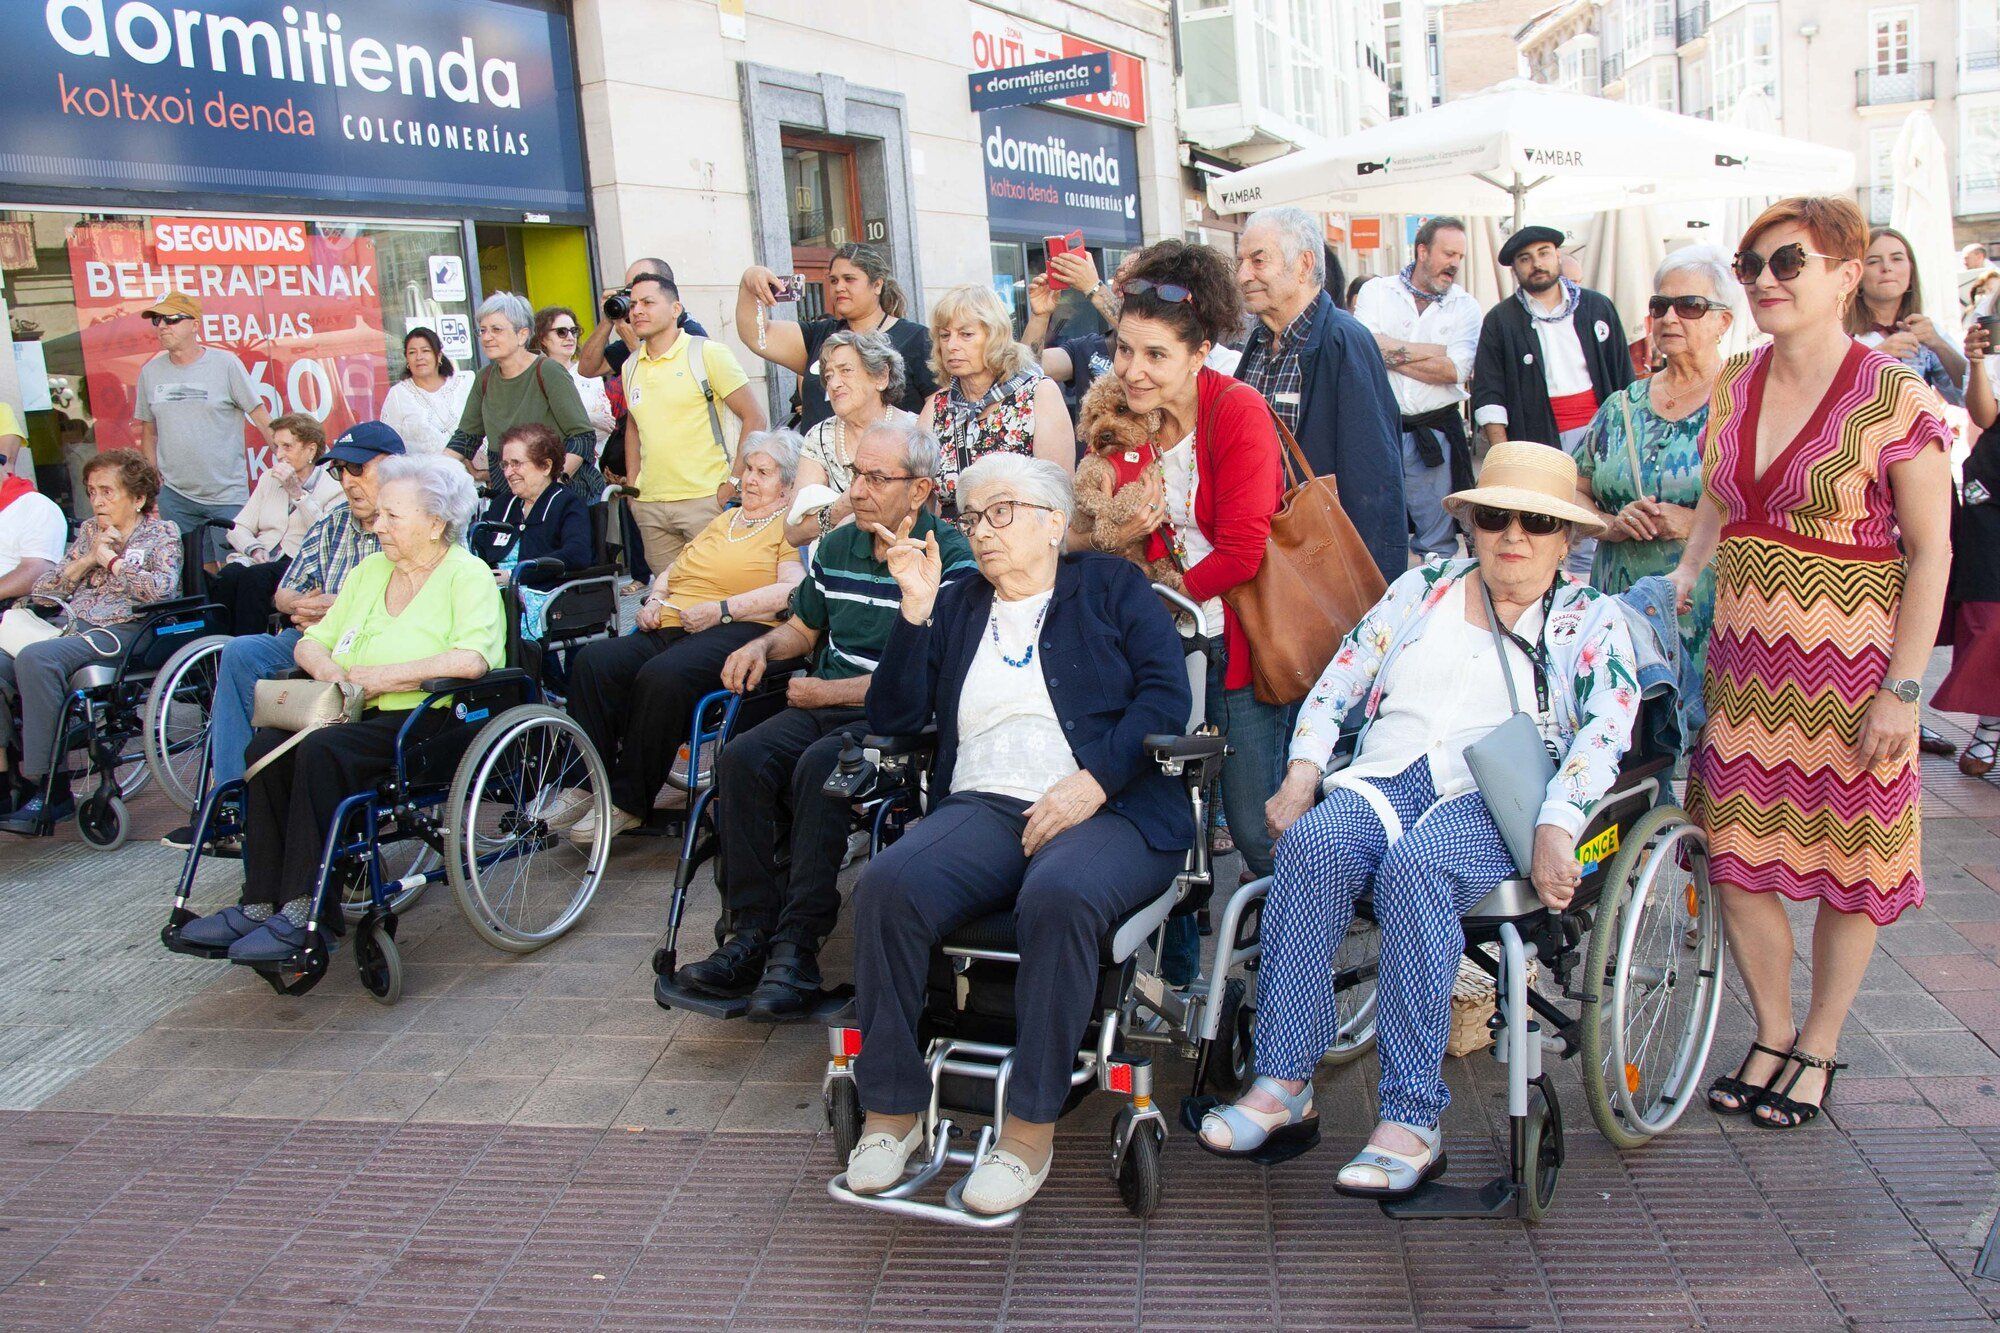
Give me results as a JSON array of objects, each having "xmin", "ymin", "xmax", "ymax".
[{"xmin": 444, "ymin": 705, "xmax": 612, "ymax": 953}]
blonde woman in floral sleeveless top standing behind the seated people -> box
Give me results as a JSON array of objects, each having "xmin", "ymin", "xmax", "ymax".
[{"xmin": 920, "ymin": 282, "xmax": 1076, "ymax": 514}]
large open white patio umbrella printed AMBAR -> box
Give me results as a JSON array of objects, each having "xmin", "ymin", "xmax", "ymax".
[{"xmin": 1208, "ymin": 78, "xmax": 1854, "ymax": 226}]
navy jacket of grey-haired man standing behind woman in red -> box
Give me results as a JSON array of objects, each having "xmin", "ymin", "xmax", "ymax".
[{"xmin": 1244, "ymin": 292, "xmax": 1410, "ymax": 582}]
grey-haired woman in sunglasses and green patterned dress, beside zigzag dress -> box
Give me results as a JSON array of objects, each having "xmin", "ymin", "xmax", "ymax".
[{"xmin": 1574, "ymin": 246, "xmax": 1744, "ymax": 681}]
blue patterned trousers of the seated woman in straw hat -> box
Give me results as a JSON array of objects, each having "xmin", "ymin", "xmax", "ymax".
[{"xmin": 1256, "ymin": 759, "xmax": 1514, "ymax": 1129}]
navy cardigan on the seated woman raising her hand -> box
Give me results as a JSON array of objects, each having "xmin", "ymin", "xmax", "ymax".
[{"xmin": 868, "ymin": 550, "xmax": 1194, "ymax": 851}]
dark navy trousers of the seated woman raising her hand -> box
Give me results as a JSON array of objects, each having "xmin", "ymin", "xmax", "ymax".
[{"xmin": 854, "ymin": 793, "xmax": 1182, "ymax": 1125}]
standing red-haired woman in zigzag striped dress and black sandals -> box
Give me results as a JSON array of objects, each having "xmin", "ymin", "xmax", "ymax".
[{"xmin": 1672, "ymin": 198, "xmax": 1952, "ymax": 1129}]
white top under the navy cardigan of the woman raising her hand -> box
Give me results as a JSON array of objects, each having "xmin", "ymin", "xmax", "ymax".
[{"xmin": 952, "ymin": 588, "xmax": 1076, "ymax": 803}]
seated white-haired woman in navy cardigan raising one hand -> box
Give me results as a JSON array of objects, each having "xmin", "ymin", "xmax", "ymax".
[{"xmin": 846, "ymin": 454, "xmax": 1194, "ymax": 1215}]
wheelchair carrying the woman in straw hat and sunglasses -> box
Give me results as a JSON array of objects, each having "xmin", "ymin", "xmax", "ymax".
[{"xmin": 1182, "ymin": 695, "xmax": 1722, "ymax": 1221}]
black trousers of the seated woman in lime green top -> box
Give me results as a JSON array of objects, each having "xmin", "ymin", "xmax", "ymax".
[{"xmin": 244, "ymin": 711, "xmax": 474, "ymax": 908}]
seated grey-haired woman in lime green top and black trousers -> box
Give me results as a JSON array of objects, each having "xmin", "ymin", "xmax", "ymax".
[{"xmin": 180, "ymin": 456, "xmax": 506, "ymax": 965}]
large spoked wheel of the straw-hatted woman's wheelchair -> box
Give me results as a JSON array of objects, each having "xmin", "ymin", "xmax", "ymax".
[{"xmin": 1580, "ymin": 807, "xmax": 1722, "ymax": 1149}]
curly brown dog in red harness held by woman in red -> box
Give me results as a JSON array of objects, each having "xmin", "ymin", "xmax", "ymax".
[{"xmin": 1074, "ymin": 374, "xmax": 1180, "ymax": 590}]
